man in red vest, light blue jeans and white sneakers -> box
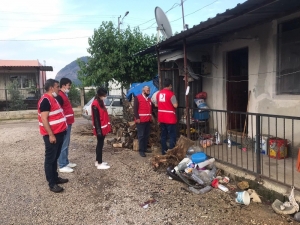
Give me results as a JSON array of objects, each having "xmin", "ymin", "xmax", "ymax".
[{"xmin": 56, "ymin": 77, "xmax": 76, "ymax": 173}]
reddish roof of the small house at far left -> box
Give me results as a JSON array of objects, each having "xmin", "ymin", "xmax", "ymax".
[{"xmin": 0, "ymin": 60, "xmax": 53, "ymax": 71}]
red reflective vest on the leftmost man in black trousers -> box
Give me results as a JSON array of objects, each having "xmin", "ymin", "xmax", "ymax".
[{"xmin": 38, "ymin": 93, "xmax": 68, "ymax": 136}]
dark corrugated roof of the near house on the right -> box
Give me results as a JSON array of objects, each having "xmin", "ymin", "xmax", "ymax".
[{"xmin": 138, "ymin": 0, "xmax": 300, "ymax": 55}]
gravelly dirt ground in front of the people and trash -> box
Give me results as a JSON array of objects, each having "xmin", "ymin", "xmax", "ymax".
[{"xmin": 0, "ymin": 118, "xmax": 297, "ymax": 225}]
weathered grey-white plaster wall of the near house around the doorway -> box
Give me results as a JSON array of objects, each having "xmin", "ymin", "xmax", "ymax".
[{"xmin": 203, "ymin": 13, "xmax": 300, "ymax": 150}]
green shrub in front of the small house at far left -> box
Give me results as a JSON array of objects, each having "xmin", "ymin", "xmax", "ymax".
[{"xmin": 8, "ymin": 80, "xmax": 27, "ymax": 111}]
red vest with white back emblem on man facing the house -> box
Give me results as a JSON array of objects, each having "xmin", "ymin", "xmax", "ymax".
[{"xmin": 156, "ymin": 89, "xmax": 177, "ymax": 124}]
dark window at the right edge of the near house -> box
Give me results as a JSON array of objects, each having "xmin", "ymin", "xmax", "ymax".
[{"xmin": 277, "ymin": 18, "xmax": 300, "ymax": 95}]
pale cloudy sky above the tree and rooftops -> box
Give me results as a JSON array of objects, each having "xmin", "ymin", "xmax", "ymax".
[{"xmin": 0, "ymin": 0, "xmax": 245, "ymax": 78}]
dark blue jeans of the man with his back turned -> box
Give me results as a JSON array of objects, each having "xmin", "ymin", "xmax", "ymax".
[{"xmin": 160, "ymin": 123, "xmax": 176, "ymax": 155}]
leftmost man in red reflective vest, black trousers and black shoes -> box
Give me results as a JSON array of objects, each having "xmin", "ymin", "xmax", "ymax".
[{"xmin": 38, "ymin": 79, "xmax": 69, "ymax": 192}]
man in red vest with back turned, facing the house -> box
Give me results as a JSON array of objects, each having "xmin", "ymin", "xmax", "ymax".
[{"xmin": 155, "ymin": 79, "xmax": 178, "ymax": 155}]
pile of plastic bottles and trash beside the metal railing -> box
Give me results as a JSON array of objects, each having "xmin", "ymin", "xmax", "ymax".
[{"xmin": 167, "ymin": 146, "xmax": 261, "ymax": 205}]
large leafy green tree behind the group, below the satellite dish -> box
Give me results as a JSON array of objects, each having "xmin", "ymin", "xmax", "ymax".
[{"xmin": 78, "ymin": 22, "xmax": 157, "ymax": 86}]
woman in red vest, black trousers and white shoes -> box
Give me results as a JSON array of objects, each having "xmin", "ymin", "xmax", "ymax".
[{"xmin": 91, "ymin": 88, "xmax": 111, "ymax": 170}]
